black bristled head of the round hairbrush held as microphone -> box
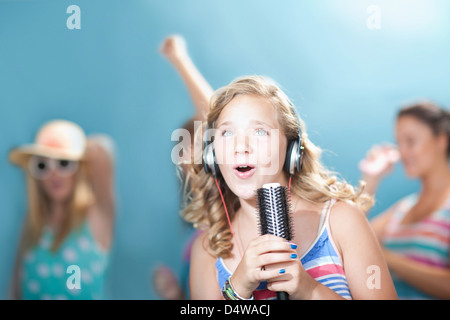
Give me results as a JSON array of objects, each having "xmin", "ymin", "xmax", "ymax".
[{"xmin": 257, "ymin": 183, "xmax": 293, "ymax": 240}]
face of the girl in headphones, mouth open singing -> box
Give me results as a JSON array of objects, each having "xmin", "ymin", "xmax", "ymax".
[{"xmin": 214, "ymin": 95, "xmax": 287, "ymax": 200}]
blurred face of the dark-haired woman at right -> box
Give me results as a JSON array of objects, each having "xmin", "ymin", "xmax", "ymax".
[{"xmin": 396, "ymin": 116, "xmax": 445, "ymax": 178}]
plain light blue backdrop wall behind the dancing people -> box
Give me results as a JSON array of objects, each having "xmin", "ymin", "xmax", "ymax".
[{"xmin": 0, "ymin": 0, "xmax": 450, "ymax": 299}]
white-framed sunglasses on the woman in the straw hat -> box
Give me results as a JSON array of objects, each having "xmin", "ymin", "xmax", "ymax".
[{"xmin": 28, "ymin": 156, "xmax": 78, "ymax": 180}]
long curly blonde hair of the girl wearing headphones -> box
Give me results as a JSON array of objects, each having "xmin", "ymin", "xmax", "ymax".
[{"xmin": 181, "ymin": 76, "xmax": 373, "ymax": 258}]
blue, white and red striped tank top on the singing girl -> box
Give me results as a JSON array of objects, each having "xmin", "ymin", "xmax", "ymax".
[{"xmin": 216, "ymin": 199, "xmax": 352, "ymax": 300}]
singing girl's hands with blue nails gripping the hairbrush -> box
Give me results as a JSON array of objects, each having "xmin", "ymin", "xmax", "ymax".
[{"xmin": 231, "ymin": 235, "xmax": 306, "ymax": 298}]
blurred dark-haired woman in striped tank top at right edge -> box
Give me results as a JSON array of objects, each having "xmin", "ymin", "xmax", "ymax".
[{"xmin": 360, "ymin": 102, "xmax": 450, "ymax": 299}]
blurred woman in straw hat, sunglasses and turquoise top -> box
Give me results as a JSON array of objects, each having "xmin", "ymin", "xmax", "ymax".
[{"xmin": 10, "ymin": 120, "xmax": 114, "ymax": 300}]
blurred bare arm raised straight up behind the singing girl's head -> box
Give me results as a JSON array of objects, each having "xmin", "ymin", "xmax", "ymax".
[{"xmin": 161, "ymin": 36, "xmax": 214, "ymax": 120}]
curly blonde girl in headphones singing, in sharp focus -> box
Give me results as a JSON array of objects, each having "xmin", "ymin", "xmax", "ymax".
[{"xmin": 182, "ymin": 76, "xmax": 397, "ymax": 300}]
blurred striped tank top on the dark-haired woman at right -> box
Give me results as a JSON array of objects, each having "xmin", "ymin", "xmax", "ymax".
[{"xmin": 383, "ymin": 194, "xmax": 450, "ymax": 299}]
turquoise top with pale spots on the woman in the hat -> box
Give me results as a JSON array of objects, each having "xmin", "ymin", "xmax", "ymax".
[{"xmin": 20, "ymin": 221, "xmax": 109, "ymax": 300}]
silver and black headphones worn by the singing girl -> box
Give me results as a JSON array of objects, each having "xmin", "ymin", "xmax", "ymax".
[{"xmin": 203, "ymin": 105, "xmax": 304, "ymax": 177}]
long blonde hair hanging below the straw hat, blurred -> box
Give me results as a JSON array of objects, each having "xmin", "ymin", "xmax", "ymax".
[{"xmin": 21, "ymin": 161, "xmax": 95, "ymax": 252}]
